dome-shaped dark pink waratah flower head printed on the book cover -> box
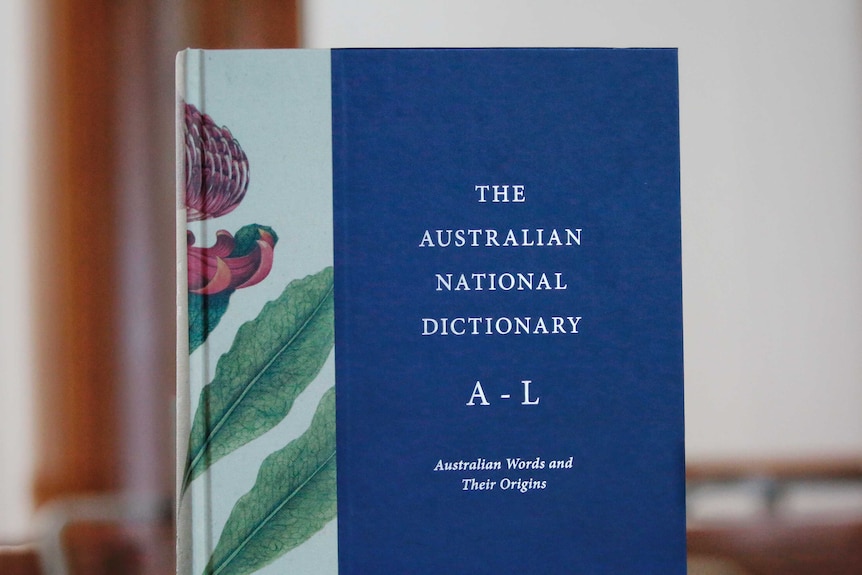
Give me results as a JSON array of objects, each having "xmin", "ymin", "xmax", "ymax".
[{"xmin": 185, "ymin": 104, "xmax": 248, "ymax": 222}]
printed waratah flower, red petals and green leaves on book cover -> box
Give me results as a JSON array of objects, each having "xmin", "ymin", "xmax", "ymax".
[{"xmin": 182, "ymin": 104, "xmax": 336, "ymax": 575}]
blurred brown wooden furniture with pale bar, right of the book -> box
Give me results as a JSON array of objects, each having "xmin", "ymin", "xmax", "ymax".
[{"xmin": 686, "ymin": 459, "xmax": 862, "ymax": 575}]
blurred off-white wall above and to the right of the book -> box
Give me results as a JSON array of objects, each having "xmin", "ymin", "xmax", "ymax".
[{"xmin": 304, "ymin": 0, "xmax": 862, "ymax": 459}]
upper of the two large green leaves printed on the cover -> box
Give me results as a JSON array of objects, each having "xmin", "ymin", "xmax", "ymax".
[{"xmin": 183, "ymin": 267, "xmax": 335, "ymax": 491}]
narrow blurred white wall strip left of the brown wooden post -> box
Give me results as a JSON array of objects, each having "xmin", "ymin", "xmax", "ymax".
[{"xmin": 0, "ymin": 0, "xmax": 36, "ymax": 543}]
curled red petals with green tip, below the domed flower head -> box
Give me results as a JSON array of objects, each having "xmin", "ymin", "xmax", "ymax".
[{"xmin": 186, "ymin": 225, "xmax": 278, "ymax": 295}]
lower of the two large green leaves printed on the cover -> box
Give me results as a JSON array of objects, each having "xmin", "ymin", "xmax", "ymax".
[{"xmin": 204, "ymin": 388, "xmax": 336, "ymax": 575}]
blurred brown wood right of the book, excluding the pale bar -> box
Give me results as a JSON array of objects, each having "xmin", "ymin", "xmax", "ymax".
[{"xmin": 686, "ymin": 458, "xmax": 862, "ymax": 575}]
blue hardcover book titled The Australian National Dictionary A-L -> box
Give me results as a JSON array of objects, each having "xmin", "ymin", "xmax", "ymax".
[{"xmin": 177, "ymin": 49, "xmax": 686, "ymax": 575}]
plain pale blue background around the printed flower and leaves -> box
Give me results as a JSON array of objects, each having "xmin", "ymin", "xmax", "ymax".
[{"xmin": 182, "ymin": 50, "xmax": 337, "ymax": 575}]
